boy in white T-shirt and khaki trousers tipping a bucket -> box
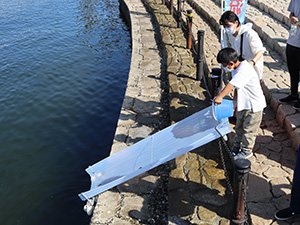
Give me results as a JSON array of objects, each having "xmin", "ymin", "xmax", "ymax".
[{"xmin": 214, "ymin": 48, "xmax": 266, "ymax": 160}]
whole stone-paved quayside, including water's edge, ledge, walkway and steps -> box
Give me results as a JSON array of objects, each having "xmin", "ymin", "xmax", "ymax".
[{"xmin": 91, "ymin": 0, "xmax": 300, "ymax": 225}]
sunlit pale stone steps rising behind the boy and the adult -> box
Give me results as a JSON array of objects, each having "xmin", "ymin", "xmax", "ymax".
[{"xmin": 175, "ymin": 0, "xmax": 300, "ymax": 149}]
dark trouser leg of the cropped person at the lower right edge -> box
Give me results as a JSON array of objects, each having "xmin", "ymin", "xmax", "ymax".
[{"xmin": 290, "ymin": 146, "xmax": 300, "ymax": 213}]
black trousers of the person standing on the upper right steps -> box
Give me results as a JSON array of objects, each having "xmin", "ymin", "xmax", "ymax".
[{"xmin": 286, "ymin": 44, "xmax": 300, "ymax": 95}]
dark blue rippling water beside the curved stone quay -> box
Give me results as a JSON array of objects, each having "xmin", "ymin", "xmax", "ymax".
[{"xmin": 0, "ymin": 0, "xmax": 131, "ymax": 225}]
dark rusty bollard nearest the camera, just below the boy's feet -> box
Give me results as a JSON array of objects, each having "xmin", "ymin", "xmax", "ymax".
[{"xmin": 231, "ymin": 159, "xmax": 251, "ymax": 225}]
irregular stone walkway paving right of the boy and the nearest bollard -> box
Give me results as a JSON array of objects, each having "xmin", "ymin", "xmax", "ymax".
[{"xmin": 231, "ymin": 107, "xmax": 300, "ymax": 225}]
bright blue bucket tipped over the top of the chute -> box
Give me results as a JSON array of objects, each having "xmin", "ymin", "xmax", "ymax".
[{"xmin": 212, "ymin": 99, "xmax": 234, "ymax": 120}]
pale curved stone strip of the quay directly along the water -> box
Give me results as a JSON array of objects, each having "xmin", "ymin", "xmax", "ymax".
[{"xmin": 90, "ymin": 0, "xmax": 169, "ymax": 225}]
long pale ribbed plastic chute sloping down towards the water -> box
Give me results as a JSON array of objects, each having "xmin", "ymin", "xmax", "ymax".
[{"xmin": 79, "ymin": 107, "xmax": 231, "ymax": 200}]
